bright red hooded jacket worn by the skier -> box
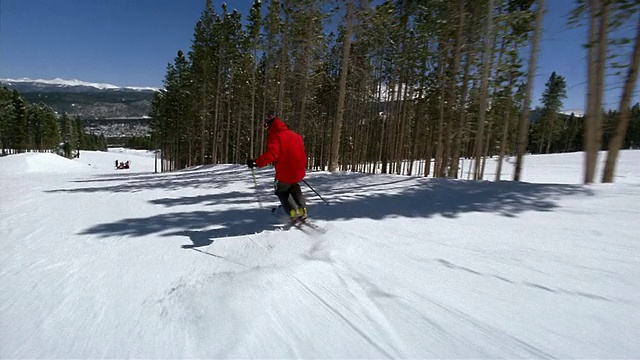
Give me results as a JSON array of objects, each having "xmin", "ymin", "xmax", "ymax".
[{"xmin": 256, "ymin": 118, "xmax": 307, "ymax": 184}]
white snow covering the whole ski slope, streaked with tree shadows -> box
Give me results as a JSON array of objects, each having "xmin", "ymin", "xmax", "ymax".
[{"xmin": 0, "ymin": 149, "xmax": 640, "ymax": 359}]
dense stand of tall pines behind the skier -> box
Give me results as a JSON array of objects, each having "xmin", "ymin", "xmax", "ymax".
[{"xmin": 151, "ymin": 0, "xmax": 638, "ymax": 180}]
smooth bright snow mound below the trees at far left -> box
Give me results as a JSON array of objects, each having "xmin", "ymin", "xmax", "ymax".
[{"xmin": 0, "ymin": 153, "xmax": 90, "ymax": 175}]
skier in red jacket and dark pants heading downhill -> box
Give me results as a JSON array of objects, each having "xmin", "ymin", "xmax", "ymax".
[{"xmin": 247, "ymin": 115, "xmax": 307, "ymax": 224}]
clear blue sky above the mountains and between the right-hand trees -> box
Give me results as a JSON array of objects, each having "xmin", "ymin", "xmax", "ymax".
[{"xmin": 0, "ymin": 0, "xmax": 638, "ymax": 109}]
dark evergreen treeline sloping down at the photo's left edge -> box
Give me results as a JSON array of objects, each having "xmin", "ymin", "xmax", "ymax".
[{"xmin": 0, "ymin": 87, "xmax": 107, "ymax": 157}]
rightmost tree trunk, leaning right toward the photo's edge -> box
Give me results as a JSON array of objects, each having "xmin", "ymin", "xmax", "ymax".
[{"xmin": 602, "ymin": 22, "xmax": 640, "ymax": 183}]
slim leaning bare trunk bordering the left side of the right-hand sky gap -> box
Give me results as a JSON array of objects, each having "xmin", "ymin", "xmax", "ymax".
[{"xmin": 513, "ymin": 0, "xmax": 545, "ymax": 181}]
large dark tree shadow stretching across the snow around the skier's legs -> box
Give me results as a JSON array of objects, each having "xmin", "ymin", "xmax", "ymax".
[{"xmin": 82, "ymin": 169, "xmax": 592, "ymax": 248}]
